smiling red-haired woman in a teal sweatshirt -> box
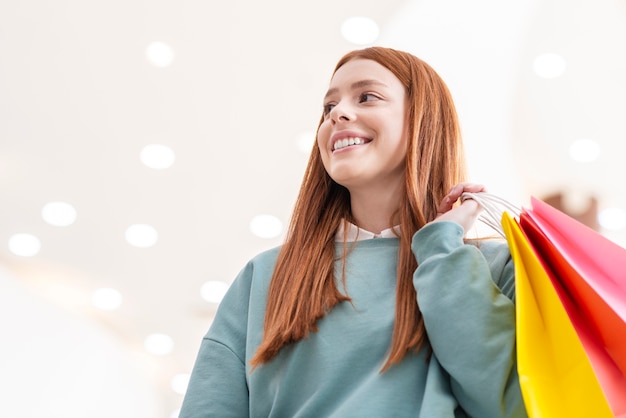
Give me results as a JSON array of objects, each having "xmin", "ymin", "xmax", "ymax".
[{"xmin": 180, "ymin": 47, "xmax": 526, "ymax": 418}]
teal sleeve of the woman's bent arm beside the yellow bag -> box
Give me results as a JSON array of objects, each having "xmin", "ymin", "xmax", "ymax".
[{"xmin": 412, "ymin": 222, "xmax": 527, "ymax": 418}]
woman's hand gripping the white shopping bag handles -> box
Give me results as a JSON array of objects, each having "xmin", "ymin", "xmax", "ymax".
[{"xmin": 433, "ymin": 183, "xmax": 486, "ymax": 232}]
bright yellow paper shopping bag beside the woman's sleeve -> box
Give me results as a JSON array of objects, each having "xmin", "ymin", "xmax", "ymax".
[{"xmin": 501, "ymin": 213, "xmax": 614, "ymax": 418}]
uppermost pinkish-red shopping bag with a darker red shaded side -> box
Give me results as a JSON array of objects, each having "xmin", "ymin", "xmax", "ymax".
[{"xmin": 520, "ymin": 198, "xmax": 626, "ymax": 374}]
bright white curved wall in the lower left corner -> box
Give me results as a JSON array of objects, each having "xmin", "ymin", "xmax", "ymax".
[{"xmin": 0, "ymin": 266, "xmax": 165, "ymax": 418}]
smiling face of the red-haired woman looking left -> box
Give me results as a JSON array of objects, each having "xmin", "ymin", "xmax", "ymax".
[{"xmin": 317, "ymin": 59, "xmax": 408, "ymax": 192}]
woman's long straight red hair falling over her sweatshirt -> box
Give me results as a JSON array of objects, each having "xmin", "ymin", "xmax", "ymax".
[{"xmin": 251, "ymin": 47, "xmax": 465, "ymax": 370}]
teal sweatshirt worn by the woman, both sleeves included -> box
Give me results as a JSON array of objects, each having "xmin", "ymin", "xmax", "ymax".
[{"xmin": 180, "ymin": 222, "xmax": 526, "ymax": 418}]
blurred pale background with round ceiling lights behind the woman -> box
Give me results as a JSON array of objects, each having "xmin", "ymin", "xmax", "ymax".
[{"xmin": 0, "ymin": 0, "xmax": 626, "ymax": 418}]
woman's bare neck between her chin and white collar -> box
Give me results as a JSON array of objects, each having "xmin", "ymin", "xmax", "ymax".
[{"xmin": 350, "ymin": 183, "xmax": 400, "ymax": 234}]
